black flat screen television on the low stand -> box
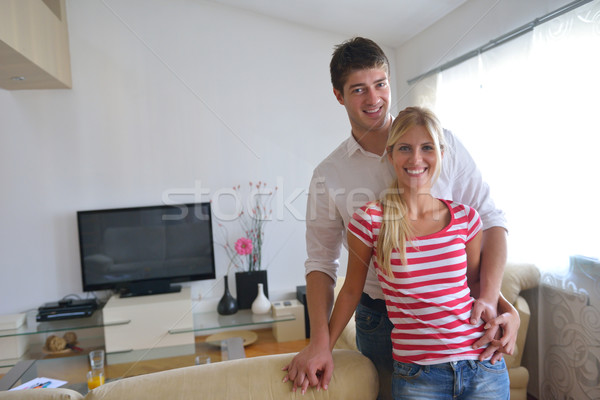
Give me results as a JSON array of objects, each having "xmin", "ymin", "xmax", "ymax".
[{"xmin": 77, "ymin": 203, "xmax": 215, "ymax": 297}]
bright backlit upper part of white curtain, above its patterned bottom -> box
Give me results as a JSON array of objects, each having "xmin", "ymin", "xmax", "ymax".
[{"xmin": 426, "ymin": 1, "xmax": 600, "ymax": 271}]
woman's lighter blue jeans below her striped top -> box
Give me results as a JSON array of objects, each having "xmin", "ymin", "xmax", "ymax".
[{"xmin": 392, "ymin": 360, "xmax": 510, "ymax": 400}]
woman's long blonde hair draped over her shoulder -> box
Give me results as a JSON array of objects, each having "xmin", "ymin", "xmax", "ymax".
[{"xmin": 377, "ymin": 107, "xmax": 445, "ymax": 276}]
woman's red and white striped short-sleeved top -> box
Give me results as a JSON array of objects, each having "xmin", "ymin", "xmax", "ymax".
[{"xmin": 348, "ymin": 200, "xmax": 484, "ymax": 365}]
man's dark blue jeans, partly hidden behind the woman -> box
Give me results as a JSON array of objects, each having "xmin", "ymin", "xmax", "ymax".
[{"xmin": 355, "ymin": 304, "xmax": 394, "ymax": 400}]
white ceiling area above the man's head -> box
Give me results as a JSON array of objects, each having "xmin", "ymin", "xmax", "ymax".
[{"xmin": 209, "ymin": 0, "xmax": 467, "ymax": 48}]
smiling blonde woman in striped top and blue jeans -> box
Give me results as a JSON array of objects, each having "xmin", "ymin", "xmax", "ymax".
[{"xmin": 329, "ymin": 107, "xmax": 509, "ymax": 400}]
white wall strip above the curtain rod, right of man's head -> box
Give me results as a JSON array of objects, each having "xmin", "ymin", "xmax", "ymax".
[{"xmin": 394, "ymin": 0, "xmax": 571, "ymax": 109}]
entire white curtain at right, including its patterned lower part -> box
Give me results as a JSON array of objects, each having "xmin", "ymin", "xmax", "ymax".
[{"xmin": 415, "ymin": 0, "xmax": 600, "ymax": 400}]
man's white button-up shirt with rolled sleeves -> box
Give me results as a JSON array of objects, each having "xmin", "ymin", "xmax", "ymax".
[{"xmin": 305, "ymin": 130, "xmax": 507, "ymax": 299}]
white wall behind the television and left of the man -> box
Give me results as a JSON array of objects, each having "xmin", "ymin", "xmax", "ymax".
[{"xmin": 0, "ymin": 0, "xmax": 393, "ymax": 314}]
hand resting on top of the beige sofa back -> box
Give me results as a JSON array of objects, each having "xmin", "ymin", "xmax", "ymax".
[{"xmin": 283, "ymin": 341, "xmax": 333, "ymax": 394}]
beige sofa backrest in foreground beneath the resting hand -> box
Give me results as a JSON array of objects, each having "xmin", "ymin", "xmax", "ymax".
[{"xmin": 85, "ymin": 350, "xmax": 379, "ymax": 400}]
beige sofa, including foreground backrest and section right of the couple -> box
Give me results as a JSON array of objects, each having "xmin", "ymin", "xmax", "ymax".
[{"xmin": 0, "ymin": 264, "xmax": 540, "ymax": 400}]
